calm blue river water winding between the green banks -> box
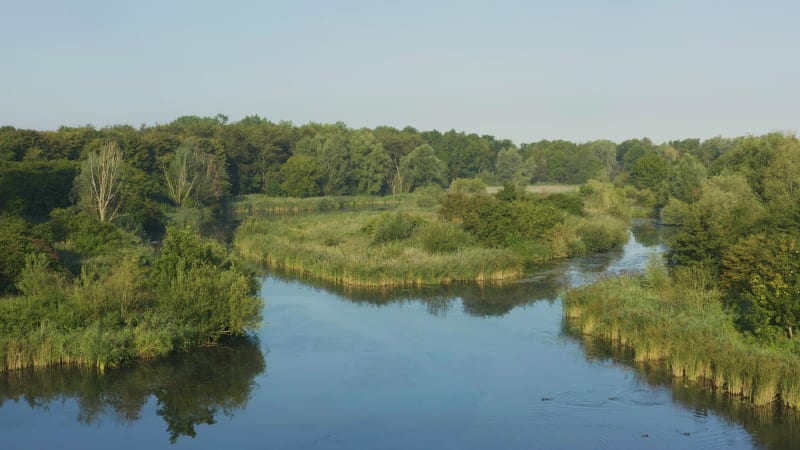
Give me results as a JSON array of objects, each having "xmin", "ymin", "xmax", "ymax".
[{"xmin": 0, "ymin": 223, "xmax": 800, "ymax": 449}]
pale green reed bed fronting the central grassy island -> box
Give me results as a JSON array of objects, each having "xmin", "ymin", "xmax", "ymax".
[{"xmin": 234, "ymin": 210, "xmax": 524, "ymax": 287}]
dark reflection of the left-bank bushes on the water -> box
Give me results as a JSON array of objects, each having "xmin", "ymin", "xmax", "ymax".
[{"xmin": 0, "ymin": 338, "xmax": 266, "ymax": 443}]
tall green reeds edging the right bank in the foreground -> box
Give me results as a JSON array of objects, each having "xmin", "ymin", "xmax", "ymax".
[{"xmin": 564, "ymin": 276, "xmax": 800, "ymax": 408}]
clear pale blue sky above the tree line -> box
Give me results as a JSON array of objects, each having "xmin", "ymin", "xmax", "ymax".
[{"xmin": 0, "ymin": 0, "xmax": 800, "ymax": 143}]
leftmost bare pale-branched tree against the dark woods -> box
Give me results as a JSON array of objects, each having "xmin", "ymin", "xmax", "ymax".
[{"xmin": 75, "ymin": 142, "xmax": 122, "ymax": 222}]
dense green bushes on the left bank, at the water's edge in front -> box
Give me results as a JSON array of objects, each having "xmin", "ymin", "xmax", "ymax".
[{"xmin": 0, "ymin": 227, "xmax": 262, "ymax": 371}]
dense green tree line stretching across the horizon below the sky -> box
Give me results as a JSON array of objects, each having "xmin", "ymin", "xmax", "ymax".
[{"xmin": 0, "ymin": 115, "xmax": 800, "ymax": 344}]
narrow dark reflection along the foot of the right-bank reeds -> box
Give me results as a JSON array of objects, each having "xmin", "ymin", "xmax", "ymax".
[{"xmin": 562, "ymin": 316, "xmax": 800, "ymax": 449}]
